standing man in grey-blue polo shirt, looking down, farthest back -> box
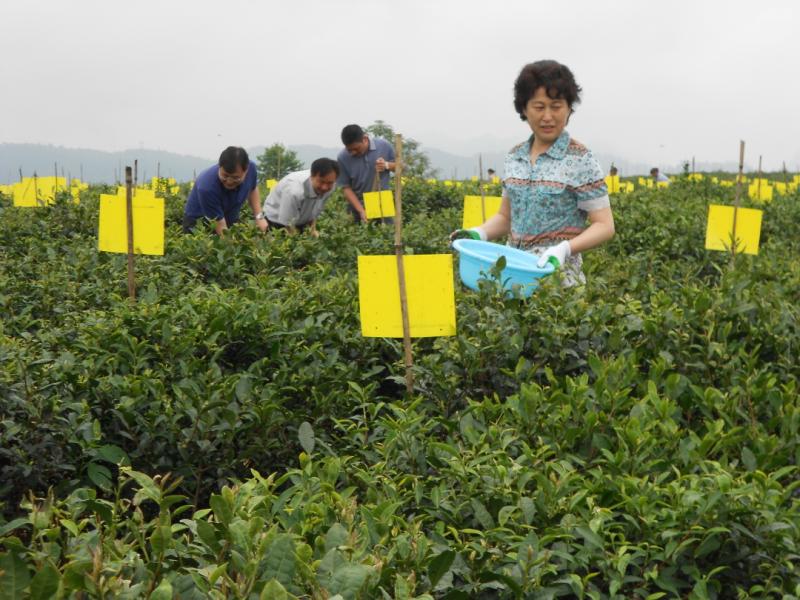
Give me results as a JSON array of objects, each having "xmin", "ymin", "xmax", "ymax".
[{"xmin": 336, "ymin": 125, "xmax": 395, "ymax": 223}]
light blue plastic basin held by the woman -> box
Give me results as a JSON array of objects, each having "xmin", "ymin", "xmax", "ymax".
[{"xmin": 453, "ymin": 240, "xmax": 555, "ymax": 296}]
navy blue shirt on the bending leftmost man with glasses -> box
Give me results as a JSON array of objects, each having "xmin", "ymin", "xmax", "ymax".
[{"xmin": 183, "ymin": 161, "xmax": 258, "ymax": 225}]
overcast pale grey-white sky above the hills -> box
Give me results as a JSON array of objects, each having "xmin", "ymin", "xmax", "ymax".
[{"xmin": 0, "ymin": 0, "xmax": 800, "ymax": 169}]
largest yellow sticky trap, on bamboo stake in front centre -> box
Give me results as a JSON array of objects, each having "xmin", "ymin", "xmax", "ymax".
[{"xmin": 358, "ymin": 254, "xmax": 456, "ymax": 338}]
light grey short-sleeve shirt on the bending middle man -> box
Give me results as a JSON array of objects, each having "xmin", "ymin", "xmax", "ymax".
[{"xmin": 264, "ymin": 169, "xmax": 333, "ymax": 227}]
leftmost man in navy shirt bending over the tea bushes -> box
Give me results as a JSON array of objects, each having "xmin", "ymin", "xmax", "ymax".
[{"xmin": 183, "ymin": 146, "xmax": 269, "ymax": 235}]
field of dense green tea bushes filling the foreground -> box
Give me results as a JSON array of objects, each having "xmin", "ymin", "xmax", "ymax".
[{"xmin": 0, "ymin": 182, "xmax": 800, "ymax": 599}]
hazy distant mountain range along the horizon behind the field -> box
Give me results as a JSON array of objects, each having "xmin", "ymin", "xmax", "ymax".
[{"xmin": 0, "ymin": 143, "xmax": 737, "ymax": 183}]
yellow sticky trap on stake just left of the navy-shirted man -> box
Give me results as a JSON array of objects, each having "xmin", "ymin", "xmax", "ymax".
[{"xmin": 97, "ymin": 191, "xmax": 164, "ymax": 256}]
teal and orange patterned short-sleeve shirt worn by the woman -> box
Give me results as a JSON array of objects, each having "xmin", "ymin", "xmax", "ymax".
[{"xmin": 503, "ymin": 130, "xmax": 610, "ymax": 245}]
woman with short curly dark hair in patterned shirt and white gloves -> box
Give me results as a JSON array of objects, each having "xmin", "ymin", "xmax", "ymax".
[{"xmin": 452, "ymin": 60, "xmax": 614, "ymax": 285}]
